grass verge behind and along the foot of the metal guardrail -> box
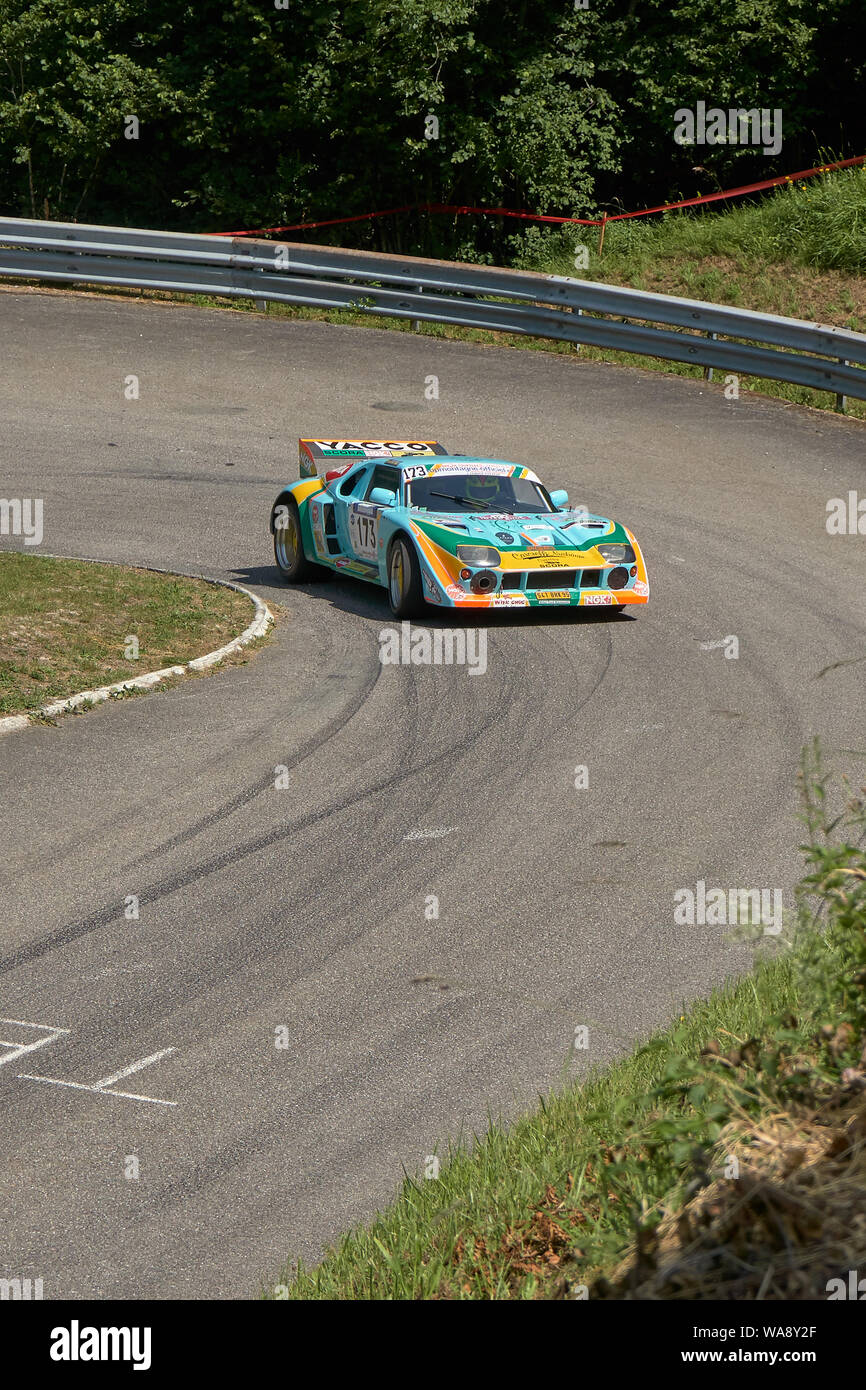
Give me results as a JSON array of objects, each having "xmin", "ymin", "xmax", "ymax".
[{"xmin": 8, "ymin": 170, "xmax": 866, "ymax": 420}]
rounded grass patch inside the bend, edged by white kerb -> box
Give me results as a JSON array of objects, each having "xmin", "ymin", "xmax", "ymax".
[{"xmin": 0, "ymin": 552, "xmax": 253, "ymax": 716}]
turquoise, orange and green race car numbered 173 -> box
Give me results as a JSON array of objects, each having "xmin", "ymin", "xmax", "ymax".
[{"xmin": 270, "ymin": 439, "xmax": 649, "ymax": 619}]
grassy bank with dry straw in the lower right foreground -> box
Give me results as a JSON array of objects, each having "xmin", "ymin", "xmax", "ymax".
[{"xmin": 265, "ymin": 745, "xmax": 866, "ymax": 1300}]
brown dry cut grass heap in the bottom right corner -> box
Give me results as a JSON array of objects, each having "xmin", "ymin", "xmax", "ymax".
[{"xmin": 583, "ymin": 1051, "xmax": 866, "ymax": 1301}]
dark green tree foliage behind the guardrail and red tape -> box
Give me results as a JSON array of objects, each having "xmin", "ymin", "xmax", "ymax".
[{"xmin": 0, "ymin": 0, "xmax": 866, "ymax": 257}]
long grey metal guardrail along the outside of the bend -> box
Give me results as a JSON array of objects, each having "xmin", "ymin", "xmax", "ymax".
[{"xmin": 0, "ymin": 218, "xmax": 866, "ymax": 409}]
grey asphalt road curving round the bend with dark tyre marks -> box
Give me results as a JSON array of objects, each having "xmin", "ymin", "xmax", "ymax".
[{"xmin": 0, "ymin": 291, "xmax": 866, "ymax": 1298}]
